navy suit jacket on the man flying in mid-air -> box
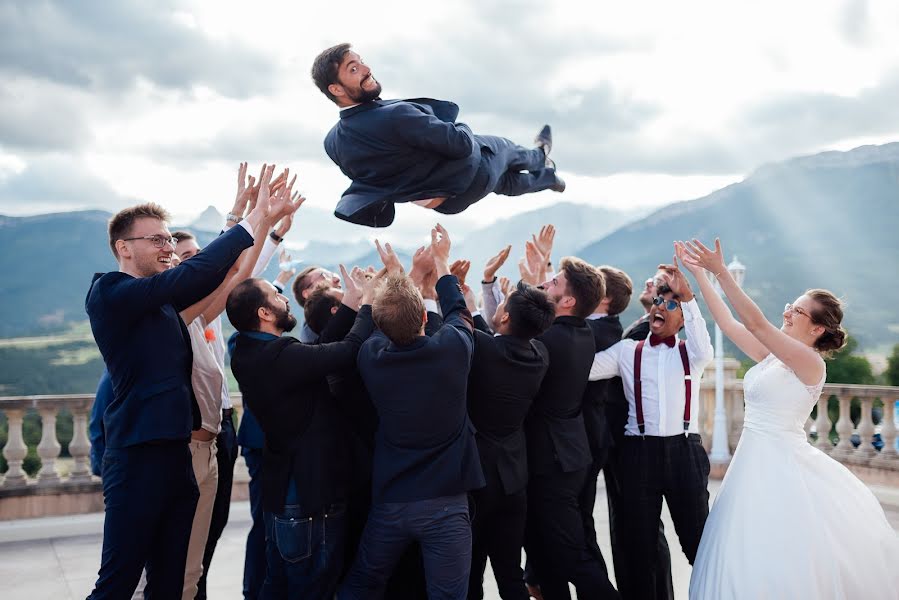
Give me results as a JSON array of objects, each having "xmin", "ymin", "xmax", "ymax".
[{"xmin": 325, "ymin": 98, "xmax": 481, "ymax": 227}]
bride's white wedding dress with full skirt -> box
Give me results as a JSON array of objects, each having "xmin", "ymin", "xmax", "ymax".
[{"xmin": 690, "ymin": 354, "xmax": 899, "ymax": 600}]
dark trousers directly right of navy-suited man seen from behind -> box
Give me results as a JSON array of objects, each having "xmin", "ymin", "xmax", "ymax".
[{"xmin": 468, "ymin": 481, "xmax": 530, "ymax": 600}]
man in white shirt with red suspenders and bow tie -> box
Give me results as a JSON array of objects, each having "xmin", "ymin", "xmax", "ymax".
[{"xmin": 589, "ymin": 264, "xmax": 714, "ymax": 598}]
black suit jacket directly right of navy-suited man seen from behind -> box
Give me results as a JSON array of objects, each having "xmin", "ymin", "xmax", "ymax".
[{"xmin": 468, "ymin": 331, "xmax": 549, "ymax": 494}]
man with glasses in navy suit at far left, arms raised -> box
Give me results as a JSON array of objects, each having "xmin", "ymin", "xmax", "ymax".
[{"xmin": 85, "ymin": 191, "xmax": 271, "ymax": 600}]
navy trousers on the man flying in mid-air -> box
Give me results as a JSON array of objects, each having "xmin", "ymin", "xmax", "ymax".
[{"xmin": 435, "ymin": 135, "xmax": 556, "ymax": 214}]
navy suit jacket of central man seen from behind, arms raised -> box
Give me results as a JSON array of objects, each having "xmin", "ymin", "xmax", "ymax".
[{"xmin": 357, "ymin": 275, "xmax": 484, "ymax": 503}]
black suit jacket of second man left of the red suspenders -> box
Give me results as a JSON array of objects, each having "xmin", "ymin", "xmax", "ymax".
[{"xmin": 525, "ymin": 317, "xmax": 596, "ymax": 475}]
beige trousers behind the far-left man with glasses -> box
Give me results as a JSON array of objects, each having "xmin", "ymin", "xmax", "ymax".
[{"xmin": 181, "ymin": 439, "xmax": 219, "ymax": 600}]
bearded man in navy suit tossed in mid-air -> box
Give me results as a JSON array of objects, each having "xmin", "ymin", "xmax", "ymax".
[{"xmin": 312, "ymin": 44, "xmax": 565, "ymax": 227}]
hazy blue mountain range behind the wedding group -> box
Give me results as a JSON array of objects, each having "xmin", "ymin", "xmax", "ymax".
[{"xmin": 0, "ymin": 143, "xmax": 899, "ymax": 348}]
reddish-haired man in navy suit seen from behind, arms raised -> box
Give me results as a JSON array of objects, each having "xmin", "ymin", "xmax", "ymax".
[{"xmin": 338, "ymin": 225, "xmax": 484, "ymax": 600}]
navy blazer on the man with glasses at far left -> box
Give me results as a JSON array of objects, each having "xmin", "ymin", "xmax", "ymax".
[{"xmin": 85, "ymin": 227, "xmax": 253, "ymax": 448}]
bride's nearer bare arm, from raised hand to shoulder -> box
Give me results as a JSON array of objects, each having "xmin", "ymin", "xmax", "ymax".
[{"xmin": 684, "ymin": 239, "xmax": 824, "ymax": 385}]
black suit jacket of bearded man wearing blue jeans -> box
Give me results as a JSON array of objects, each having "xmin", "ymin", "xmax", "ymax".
[{"xmin": 231, "ymin": 306, "xmax": 374, "ymax": 514}]
